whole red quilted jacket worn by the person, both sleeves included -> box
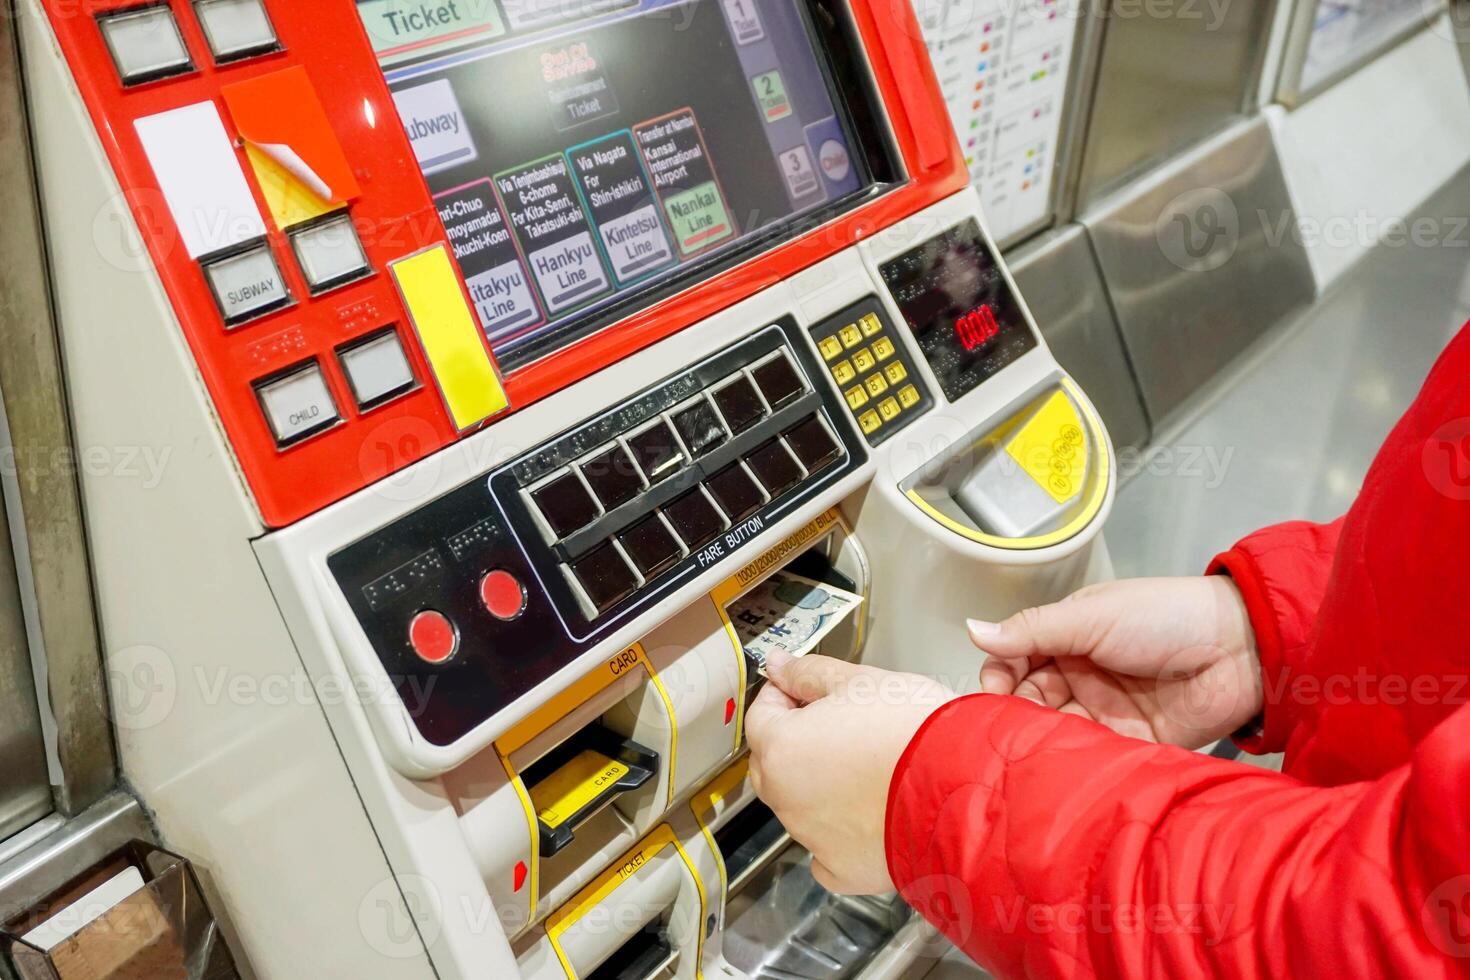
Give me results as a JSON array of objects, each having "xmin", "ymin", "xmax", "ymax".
[{"xmin": 886, "ymin": 326, "xmax": 1470, "ymax": 979}]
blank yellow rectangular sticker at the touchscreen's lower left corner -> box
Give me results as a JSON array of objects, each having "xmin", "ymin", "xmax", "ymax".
[{"xmin": 390, "ymin": 245, "xmax": 510, "ymax": 432}]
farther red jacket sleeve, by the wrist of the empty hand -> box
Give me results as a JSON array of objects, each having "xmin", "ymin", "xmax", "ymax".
[{"xmin": 1208, "ymin": 519, "xmax": 1344, "ymax": 754}]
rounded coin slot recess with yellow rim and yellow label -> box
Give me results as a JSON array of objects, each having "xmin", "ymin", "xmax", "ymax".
[{"xmin": 900, "ymin": 378, "xmax": 1111, "ymax": 550}]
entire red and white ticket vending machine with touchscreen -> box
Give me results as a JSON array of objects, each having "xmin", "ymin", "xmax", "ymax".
[{"xmin": 21, "ymin": 0, "xmax": 1116, "ymax": 980}]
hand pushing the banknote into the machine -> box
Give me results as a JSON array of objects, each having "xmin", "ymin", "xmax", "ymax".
[{"xmin": 745, "ymin": 655, "xmax": 954, "ymax": 895}]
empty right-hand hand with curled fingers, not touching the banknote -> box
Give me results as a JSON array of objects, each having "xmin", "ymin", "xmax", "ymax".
[{"xmin": 969, "ymin": 576, "xmax": 1263, "ymax": 748}]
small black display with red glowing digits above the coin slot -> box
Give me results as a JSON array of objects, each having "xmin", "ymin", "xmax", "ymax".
[{"xmin": 881, "ymin": 219, "xmax": 1036, "ymax": 401}]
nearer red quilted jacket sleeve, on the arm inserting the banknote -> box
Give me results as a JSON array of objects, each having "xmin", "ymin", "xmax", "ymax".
[{"xmin": 886, "ymin": 695, "xmax": 1470, "ymax": 979}]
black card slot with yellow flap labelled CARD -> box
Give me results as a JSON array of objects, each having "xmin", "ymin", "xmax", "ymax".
[{"xmin": 523, "ymin": 721, "xmax": 659, "ymax": 858}]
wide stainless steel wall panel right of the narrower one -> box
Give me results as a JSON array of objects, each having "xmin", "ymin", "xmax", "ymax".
[{"xmin": 1080, "ymin": 119, "xmax": 1316, "ymax": 429}]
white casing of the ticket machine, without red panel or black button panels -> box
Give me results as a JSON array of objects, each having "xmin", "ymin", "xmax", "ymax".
[{"xmin": 14, "ymin": 4, "xmax": 1116, "ymax": 980}]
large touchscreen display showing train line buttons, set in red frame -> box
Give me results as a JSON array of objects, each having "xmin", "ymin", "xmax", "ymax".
[{"xmin": 366, "ymin": 0, "xmax": 873, "ymax": 369}]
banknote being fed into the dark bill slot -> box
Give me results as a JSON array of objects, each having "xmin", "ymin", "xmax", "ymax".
[{"xmin": 729, "ymin": 572, "xmax": 863, "ymax": 676}]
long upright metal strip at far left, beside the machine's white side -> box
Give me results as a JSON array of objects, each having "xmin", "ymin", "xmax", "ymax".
[{"xmin": 0, "ymin": 0, "xmax": 118, "ymax": 817}]
